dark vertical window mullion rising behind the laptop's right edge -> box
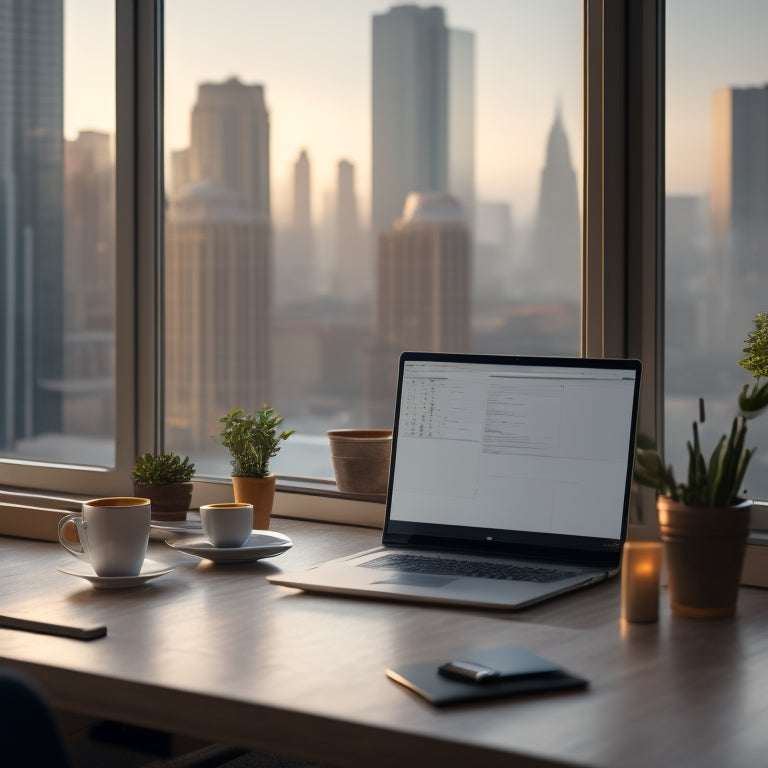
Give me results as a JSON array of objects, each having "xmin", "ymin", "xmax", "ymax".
[{"xmin": 582, "ymin": 0, "xmax": 664, "ymax": 535}]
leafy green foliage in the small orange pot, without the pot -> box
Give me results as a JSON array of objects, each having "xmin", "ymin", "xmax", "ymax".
[{"xmin": 219, "ymin": 403, "xmax": 295, "ymax": 477}]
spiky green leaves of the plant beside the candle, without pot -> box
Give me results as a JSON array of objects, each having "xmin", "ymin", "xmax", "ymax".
[{"xmin": 634, "ymin": 312, "xmax": 768, "ymax": 507}]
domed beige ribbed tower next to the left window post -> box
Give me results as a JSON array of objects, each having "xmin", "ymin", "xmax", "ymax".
[{"xmin": 165, "ymin": 181, "xmax": 271, "ymax": 451}]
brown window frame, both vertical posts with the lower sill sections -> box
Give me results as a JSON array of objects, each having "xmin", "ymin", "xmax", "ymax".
[{"xmin": 0, "ymin": 0, "xmax": 665, "ymax": 533}]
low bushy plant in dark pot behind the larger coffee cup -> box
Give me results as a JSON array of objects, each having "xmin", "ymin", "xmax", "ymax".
[{"xmin": 131, "ymin": 453, "xmax": 195, "ymax": 521}]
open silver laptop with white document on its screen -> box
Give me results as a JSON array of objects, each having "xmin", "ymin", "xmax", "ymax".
[{"xmin": 267, "ymin": 352, "xmax": 641, "ymax": 609}]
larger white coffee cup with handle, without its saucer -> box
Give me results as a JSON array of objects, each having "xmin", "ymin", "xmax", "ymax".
[{"xmin": 59, "ymin": 496, "xmax": 151, "ymax": 576}]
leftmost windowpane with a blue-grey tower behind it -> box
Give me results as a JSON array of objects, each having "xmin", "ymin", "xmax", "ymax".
[{"xmin": 0, "ymin": 0, "xmax": 115, "ymax": 466}]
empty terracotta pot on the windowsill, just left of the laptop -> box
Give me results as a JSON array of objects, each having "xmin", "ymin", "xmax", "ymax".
[{"xmin": 328, "ymin": 429, "xmax": 392, "ymax": 495}]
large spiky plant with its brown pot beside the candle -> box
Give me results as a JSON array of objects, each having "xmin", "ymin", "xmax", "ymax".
[{"xmin": 634, "ymin": 313, "xmax": 768, "ymax": 618}]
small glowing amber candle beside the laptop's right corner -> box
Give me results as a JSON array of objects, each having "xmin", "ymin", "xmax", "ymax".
[{"xmin": 621, "ymin": 541, "xmax": 661, "ymax": 621}]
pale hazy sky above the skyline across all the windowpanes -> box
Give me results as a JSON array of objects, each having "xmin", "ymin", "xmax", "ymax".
[{"xmin": 65, "ymin": 0, "xmax": 768, "ymax": 220}]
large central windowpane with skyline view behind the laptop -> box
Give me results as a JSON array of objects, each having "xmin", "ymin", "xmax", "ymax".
[{"xmin": 165, "ymin": 0, "xmax": 582, "ymax": 478}]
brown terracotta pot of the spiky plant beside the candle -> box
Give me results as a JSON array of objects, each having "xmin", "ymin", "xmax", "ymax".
[{"xmin": 657, "ymin": 496, "xmax": 752, "ymax": 619}]
